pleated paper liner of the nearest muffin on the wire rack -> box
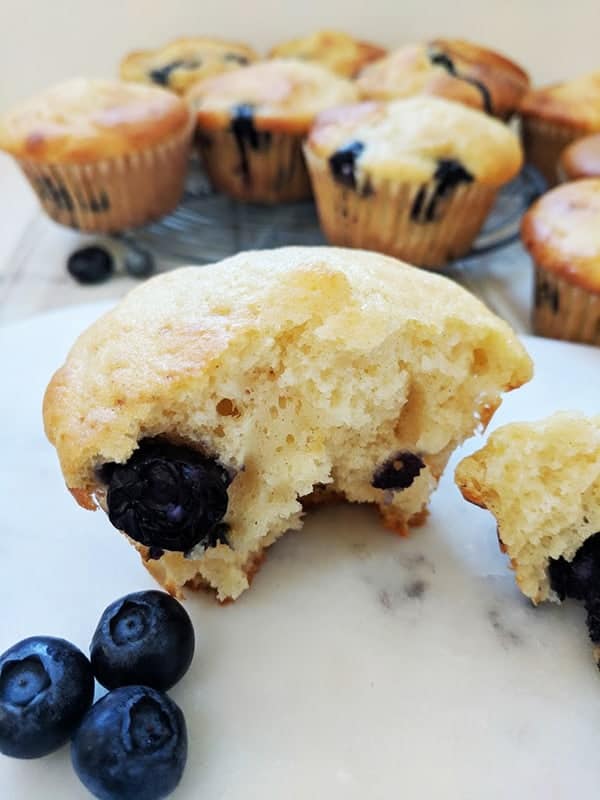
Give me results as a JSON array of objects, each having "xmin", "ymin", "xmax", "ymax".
[{"xmin": 306, "ymin": 151, "xmax": 498, "ymax": 269}]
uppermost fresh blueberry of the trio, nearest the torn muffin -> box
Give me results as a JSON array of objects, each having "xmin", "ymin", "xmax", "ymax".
[{"xmin": 90, "ymin": 591, "xmax": 194, "ymax": 691}]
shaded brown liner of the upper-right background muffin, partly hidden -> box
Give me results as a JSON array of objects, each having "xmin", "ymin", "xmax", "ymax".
[{"xmin": 521, "ymin": 117, "xmax": 588, "ymax": 186}]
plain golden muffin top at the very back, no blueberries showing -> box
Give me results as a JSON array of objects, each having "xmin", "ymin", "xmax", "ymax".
[{"xmin": 269, "ymin": 31, "xmax": 386, "ymax": 78}]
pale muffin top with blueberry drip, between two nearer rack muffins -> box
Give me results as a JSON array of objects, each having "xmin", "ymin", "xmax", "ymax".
[{"xmin": 187, "ymin": 59, "xmax": 358, "ymax": 133}]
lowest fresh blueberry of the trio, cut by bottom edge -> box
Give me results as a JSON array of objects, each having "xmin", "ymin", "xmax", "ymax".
[{"xmin": 71, "ymin": 686, "xmax": 187, "ymax": 800}]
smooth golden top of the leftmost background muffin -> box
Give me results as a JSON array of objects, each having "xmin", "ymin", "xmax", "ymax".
[{"xmin": 0, "ymin": 78, "xmax": 190, "ymax": 163}]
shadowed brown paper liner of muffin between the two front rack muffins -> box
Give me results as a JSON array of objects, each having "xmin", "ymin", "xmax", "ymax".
[{"xmin": 197, "ymin": 129, "xmax": 312, "ymax": 205}]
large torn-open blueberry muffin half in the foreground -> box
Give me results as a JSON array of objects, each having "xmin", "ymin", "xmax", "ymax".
[{"xmin": 44, "ymin": 247, "xmax": 531, "ymax": 600}]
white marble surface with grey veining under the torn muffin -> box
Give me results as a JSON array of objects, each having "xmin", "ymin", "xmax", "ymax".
[{"xmin": 0, "ymin": 306, "xmax": 600, "ymax": 800}]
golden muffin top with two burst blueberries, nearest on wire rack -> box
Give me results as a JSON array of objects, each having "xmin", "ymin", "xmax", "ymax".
[{"xmin": 307, "ymin": 96, "xmax": 522, "ymax": 189}]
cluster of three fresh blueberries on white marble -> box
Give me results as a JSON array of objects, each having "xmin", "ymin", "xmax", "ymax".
[{"xmin": 0, "ymin": 591, "xmax": 194, "ymax": 800}]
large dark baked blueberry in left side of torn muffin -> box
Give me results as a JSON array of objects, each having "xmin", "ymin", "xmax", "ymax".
[{"xmin": 101, "ymin": 439, "xmax": 231, "ymax": 552}]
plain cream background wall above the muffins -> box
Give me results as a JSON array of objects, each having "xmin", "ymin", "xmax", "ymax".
[{"xmin": 0, "ymin": 0, "xmax": 600, "ymax": 108}]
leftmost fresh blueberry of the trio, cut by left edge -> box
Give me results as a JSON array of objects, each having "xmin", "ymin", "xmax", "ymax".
[{"xmin": 0, "ymin": 636, "xmax": 94, "ymax": 758}]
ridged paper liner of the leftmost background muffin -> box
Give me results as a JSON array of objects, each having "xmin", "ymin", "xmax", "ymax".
[{"xmin": 18, "ymin": 126, "xmax": 192, "ymax": 233}]
